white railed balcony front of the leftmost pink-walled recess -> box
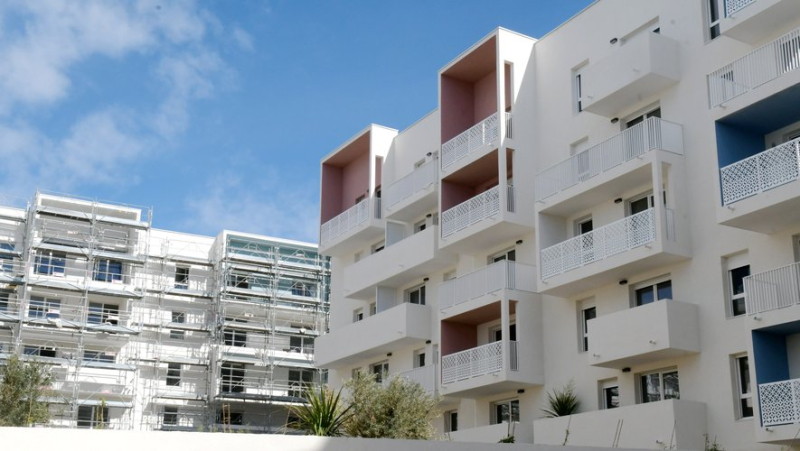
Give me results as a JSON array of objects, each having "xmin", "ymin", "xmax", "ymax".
[{"xmin": 319, "ymin": 198, "xmax": 383, "ymax": 254}]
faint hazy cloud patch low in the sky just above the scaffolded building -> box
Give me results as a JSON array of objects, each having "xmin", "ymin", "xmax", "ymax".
[{"xmin": 182, "ymin": 169, "xmax": 319, "ymax": 243}]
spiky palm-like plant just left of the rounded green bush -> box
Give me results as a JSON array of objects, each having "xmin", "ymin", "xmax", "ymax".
[{"xmin": 289, "ymin": 386, "xmax": 352, "ymax": 437}]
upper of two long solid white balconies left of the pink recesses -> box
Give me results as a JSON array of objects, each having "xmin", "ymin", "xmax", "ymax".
[{"xmin": 344, "ymin": 226, "xmax": 455, "ymax": 299}]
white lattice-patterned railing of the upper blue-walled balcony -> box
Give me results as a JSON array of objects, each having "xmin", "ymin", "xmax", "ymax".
[{"xmin": 719, "ymin": 138, "xmax": 800, "ymax": 205}]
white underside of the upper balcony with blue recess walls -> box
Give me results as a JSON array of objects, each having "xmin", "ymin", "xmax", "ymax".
[{"xmin": 717, "ymin": 180, "xmax": 800, "ymax": 234}]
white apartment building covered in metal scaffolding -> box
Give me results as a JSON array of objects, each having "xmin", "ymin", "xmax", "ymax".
[{"xmin": 0, "ymin": 193, "xmax": 330, "ymax": 433}]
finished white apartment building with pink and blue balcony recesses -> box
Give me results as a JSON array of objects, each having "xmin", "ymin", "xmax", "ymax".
[{"xmin": 315, "ymin": 0, "xmax": 800, "ymax": 451}]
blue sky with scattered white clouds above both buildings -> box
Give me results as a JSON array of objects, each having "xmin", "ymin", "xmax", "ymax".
[{"xmin": 0, "ymin": 0, "xmax": 591, "ymax": 242}]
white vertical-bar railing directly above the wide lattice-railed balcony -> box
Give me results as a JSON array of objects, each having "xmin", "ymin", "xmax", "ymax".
[{"xmin": 536, "ymin": 117, "xmax": 683, "ymax": 202}]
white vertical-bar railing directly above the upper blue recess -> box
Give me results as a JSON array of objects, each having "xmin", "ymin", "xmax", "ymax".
[{"xmin": 706, "ymin": 26, "xmax": 800, "ymax": 108}]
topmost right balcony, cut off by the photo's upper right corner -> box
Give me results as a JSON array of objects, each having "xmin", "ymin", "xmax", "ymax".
[{"xmin": 719, "ymin": 0, "xmax": 800, "ymax": 44}]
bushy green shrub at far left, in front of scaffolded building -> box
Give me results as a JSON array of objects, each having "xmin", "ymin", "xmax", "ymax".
[{"xmin": 0, "ymin": 356, "xmax": 53, "ymax": 426}]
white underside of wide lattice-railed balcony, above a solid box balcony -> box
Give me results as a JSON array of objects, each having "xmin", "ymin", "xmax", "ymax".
[{"xmin": 539, "ymin": 244, "xmax": 689, "ymax": 297}]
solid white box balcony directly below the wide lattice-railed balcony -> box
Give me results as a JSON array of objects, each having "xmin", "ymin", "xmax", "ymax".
[{"xmin": 588, "ymin": 300, "xmax": 700, "ymax": 369}]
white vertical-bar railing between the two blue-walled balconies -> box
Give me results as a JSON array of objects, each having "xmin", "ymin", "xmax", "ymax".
[{"xmin": 744, "ymin": 263, "xmax": 800, "ymax": 315}]
